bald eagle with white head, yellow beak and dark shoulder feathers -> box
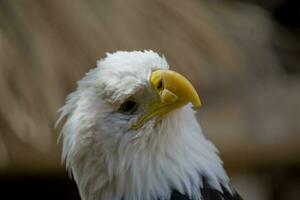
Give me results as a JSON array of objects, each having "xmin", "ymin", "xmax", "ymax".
[{"xmin": 58, "ymin": 50, "xmax": 241, "ymax": 200}]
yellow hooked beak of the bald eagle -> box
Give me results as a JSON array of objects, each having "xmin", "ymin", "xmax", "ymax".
[{"xmin": 132, "ymin": 70, "xmax": 201, "ymax": 129}]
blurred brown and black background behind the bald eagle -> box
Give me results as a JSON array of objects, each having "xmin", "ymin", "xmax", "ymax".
[{"xmin": 0, "ymin": 0, "xmax": 300, "ymax": 200}]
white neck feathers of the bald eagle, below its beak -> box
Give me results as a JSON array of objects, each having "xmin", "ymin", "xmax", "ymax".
[{"xmin": 67, "ymin": 105, "xmax": 230, "ymax": 200}]
